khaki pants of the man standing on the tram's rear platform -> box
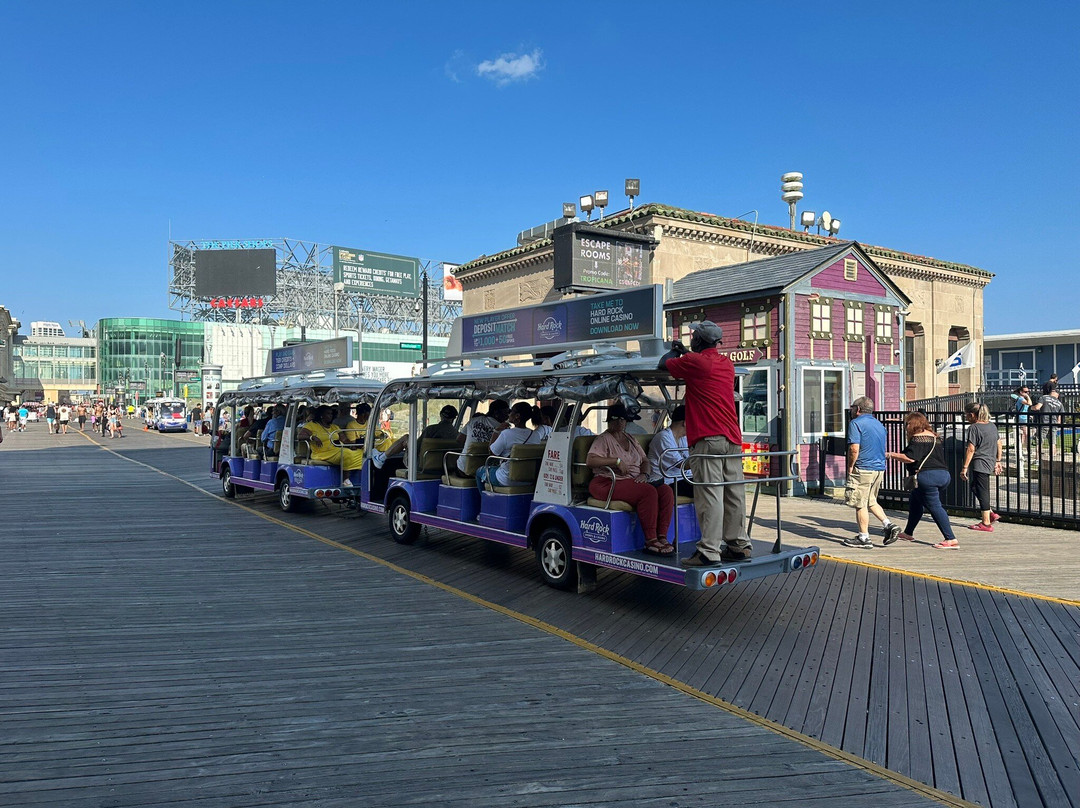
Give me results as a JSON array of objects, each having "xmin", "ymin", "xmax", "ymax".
[{"xmin": 690, "ymin": 435, "xmax": 750, "ymax": 561}]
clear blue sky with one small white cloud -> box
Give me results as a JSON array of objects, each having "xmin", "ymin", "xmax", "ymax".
[{"xmin": 0, "ymin": 0, "xmax": 1080, "ymax": 334}]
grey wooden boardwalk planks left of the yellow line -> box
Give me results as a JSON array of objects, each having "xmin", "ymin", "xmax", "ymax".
[{"xmin": 0, "ymin": 430, "xmax": 934, "ymax": 808}]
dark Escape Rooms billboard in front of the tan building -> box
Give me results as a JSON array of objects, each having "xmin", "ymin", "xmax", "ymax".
[{"xmin": 552, "ymin": 223, "xmax": 657, "ymax": 289}]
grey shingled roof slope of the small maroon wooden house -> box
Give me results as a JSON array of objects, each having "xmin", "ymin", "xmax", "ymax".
[{"xmin": 667, "ymin": 241, "xmax": 858, "ymax": 305}]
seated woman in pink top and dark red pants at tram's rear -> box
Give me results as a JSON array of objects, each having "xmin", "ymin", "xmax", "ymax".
[{"xmin": 585, "ymin": 404, "xmax": 675, "ymax": 555}]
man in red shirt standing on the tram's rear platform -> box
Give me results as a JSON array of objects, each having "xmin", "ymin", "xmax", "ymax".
[{"xmin": 660, "ymin": 320, "xmax": 751, "ymax": 567}]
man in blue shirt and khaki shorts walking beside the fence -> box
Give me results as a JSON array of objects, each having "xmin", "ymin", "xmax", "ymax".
[{"xmin": 843, "ymin": 395, "xmax": 900, "ymax": 550}]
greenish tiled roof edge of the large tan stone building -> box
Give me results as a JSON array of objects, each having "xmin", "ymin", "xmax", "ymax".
[{"xmin": 454, "ymin": 202, "xmax": 994, "ymax": 281}]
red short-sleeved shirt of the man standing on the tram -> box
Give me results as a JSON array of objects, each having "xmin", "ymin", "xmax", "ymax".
[{"xmin": 665, "ymin": 348, "xmax": 742, "ymax": 447}]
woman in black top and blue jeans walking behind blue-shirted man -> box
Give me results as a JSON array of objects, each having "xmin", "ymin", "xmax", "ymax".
[{"xmin": 888, "ymin": 413, "xmax": 960, "ymax": 550}]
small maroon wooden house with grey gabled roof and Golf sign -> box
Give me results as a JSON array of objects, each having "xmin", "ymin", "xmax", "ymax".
[{"xmin": 664, "ymin": 241, "xmax": 910, "ymax": 495}]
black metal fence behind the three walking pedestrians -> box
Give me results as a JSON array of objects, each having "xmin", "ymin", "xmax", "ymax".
[{"xmin": 876, "ymin": 410, "xmax": 1080, "ymax": 529}]
